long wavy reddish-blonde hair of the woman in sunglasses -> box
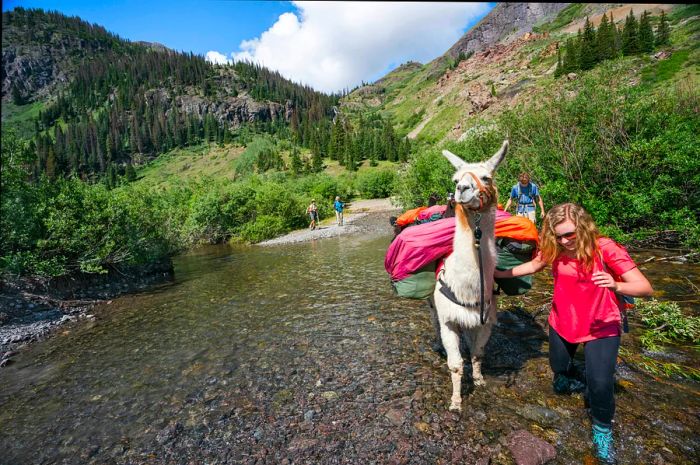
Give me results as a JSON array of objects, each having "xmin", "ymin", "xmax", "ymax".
[{"xmin": 540, "ymin": 203, "xmax": 600, "ymax": 271}]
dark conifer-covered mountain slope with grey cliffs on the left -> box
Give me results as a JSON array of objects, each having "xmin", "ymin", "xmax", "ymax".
[{"xmin": 2, "ymin": 8, "xmax": 338, "ymax": 178}]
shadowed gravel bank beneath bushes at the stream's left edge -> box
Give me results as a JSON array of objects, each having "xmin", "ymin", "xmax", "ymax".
[{"xmin": 0, "ymin": 259, "xmax": 173, "ymax": 367}]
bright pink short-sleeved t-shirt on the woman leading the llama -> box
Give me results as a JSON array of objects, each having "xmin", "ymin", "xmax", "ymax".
[{"xmin": 549, "ymin": 237, "xmax": 637, "ymax": 343}]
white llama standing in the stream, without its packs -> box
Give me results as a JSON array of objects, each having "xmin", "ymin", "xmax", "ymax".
[{"xmin": 433, "ymin": 140, "xmax": 508, "ymax": 412}]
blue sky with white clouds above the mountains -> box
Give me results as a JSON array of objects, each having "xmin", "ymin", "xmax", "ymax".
[{"xmin": 3, "ymin": 0, "xmax": 495, "ymax": 92}]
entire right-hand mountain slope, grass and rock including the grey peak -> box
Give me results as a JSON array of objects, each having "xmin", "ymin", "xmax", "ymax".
[{"xmin": 348, "ymin": 4, "xmax": 698, "ymax": 143}]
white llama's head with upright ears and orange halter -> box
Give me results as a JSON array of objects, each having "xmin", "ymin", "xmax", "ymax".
[{"xmin": 442, "ymin": 140, "xmax": 508, "ymax": 210}]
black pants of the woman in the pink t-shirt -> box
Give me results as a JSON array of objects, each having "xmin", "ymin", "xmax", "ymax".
[{"xmin": 549, "ymin": 327, "xmax": 620, "ymax": 426}]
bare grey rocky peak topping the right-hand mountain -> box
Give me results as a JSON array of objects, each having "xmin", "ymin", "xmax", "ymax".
[{"xmin": 446, "ymin": 3, "xmax": 569, "ymax": 57}]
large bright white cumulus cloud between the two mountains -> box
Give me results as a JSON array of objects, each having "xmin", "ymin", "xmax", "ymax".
[{"xmin": 207, "ymin": 2, "xmax": 489, "ymax": 92}]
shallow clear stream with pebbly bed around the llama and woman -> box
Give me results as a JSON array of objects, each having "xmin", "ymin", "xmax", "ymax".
[{"xmin": 0, "ymin": 213, "xmax": 700, "ymax": 464}]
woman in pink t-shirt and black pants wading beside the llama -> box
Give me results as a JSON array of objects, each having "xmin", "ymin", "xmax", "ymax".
[{"xmin": 494, "ymin": 203, "xmax": 653, "ymax": 464}]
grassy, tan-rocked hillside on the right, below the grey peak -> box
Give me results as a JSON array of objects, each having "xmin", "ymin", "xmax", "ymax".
[{"xmin": 342, "ymin": 4, "xmax": 700, "ymax": 144}]
